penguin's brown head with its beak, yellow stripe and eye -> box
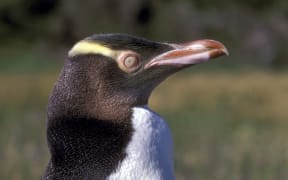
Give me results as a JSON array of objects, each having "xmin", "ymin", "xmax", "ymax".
[{"xmin": 52, "ymin": 34, "xmax": 228, "ymax": 120}]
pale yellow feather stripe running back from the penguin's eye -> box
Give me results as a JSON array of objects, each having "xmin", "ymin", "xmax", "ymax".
[{"xmin": 68, "ymin": 40, "xmax": 118, "ymax": 59}]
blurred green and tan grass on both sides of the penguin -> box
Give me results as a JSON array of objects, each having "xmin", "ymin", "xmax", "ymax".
[{"xmin": 0, "ymin": 53, "xmax": 288, "ymax": 180}]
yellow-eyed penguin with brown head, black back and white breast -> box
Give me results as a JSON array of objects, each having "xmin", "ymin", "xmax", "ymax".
[{"xmin": 43, "ymin": 34, "xmax": 228, "ymax": 180}]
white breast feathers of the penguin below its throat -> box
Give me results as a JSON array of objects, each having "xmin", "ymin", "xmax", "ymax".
[{"xmin": 108, "ymin": 106, "xmax": 174, "ymax": 180}]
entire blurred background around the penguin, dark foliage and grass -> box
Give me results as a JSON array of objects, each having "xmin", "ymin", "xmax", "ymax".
[{"xmin": 0, "ymin": 0, "xmax": 288, "ymax": 180}]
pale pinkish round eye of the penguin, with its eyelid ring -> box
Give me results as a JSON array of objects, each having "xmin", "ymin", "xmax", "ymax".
[{"xmin": 119, "ymin": 52, "xmax": 141, "ymax": 73}]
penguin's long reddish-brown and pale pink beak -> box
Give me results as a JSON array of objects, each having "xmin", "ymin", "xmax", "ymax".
[{"xmin": 144, "ymin": 39, "xmax": 229, "ymax": 69}]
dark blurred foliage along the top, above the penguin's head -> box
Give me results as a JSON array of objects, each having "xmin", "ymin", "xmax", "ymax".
[{"xmin": 0, "ymin": 0, "xmax": 288, "ymax": 67}]
